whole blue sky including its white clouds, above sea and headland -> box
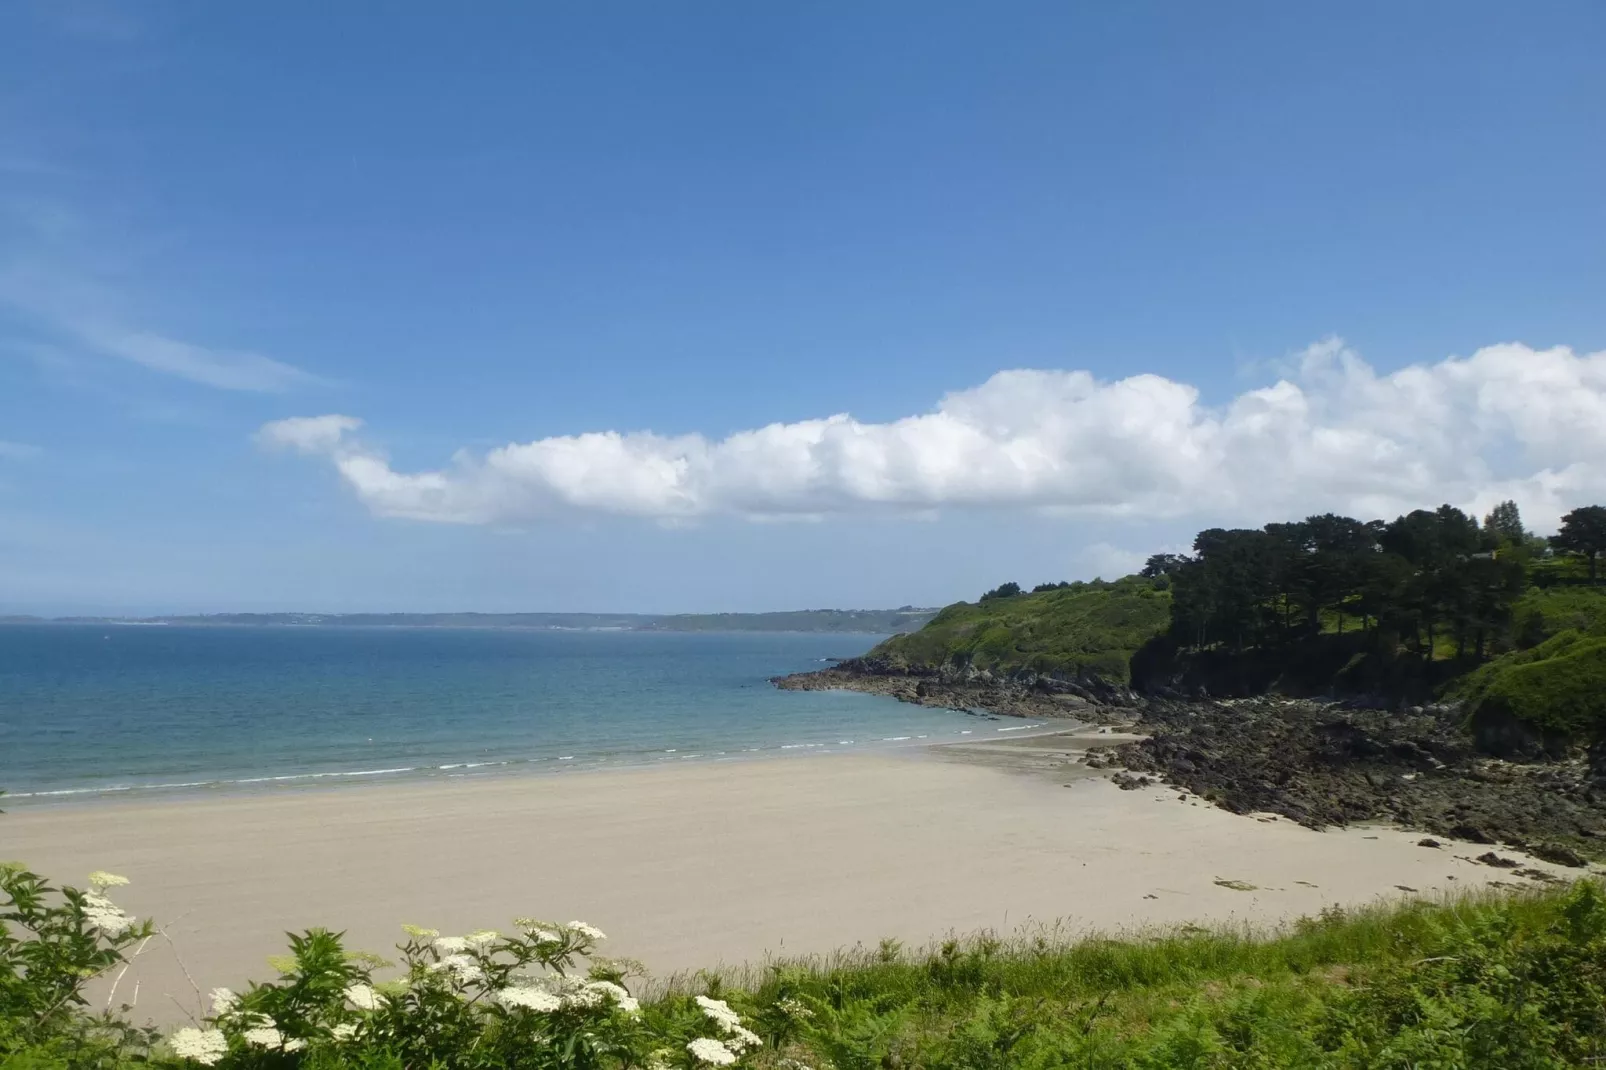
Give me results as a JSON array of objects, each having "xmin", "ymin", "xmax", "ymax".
[{"xmin": 0, "ymin": 0, "xmax": 1606, "ymax": 614}]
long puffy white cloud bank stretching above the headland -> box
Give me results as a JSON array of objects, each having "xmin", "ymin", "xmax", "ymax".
[{"xmin": 257, "ymin": 339, "xmax": 1606, "ymax": 530}]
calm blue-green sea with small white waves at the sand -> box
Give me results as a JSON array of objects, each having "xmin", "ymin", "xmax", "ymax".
[{"xmin": 0, "ymin": 625, "xmax": 999, "ymax": 805}]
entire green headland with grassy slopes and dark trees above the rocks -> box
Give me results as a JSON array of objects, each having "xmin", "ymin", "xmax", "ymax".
[{"xmin": 867, "ymin": 501, "xmax": 1606, "ymax": 745}]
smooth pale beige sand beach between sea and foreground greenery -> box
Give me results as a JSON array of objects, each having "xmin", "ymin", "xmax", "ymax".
[{"xmin": 0, "ymin": 741, "xmax": 1566, "ymax": 1022}]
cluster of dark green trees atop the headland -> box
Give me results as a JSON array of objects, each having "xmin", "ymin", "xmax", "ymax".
[{"xmin": 1143, "ymin": 501, "xmax": 1606, "ymax": 659}]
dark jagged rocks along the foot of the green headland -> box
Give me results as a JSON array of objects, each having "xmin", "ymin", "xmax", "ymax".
[{"xmin": 774, "ymin": 659, "xmax": 1606, "ymax": 866}]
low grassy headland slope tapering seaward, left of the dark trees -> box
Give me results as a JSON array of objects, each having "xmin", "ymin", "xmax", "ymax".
[{"xmin": 869, "ymin": 577, "xmax": 1171, "ymax": 683}]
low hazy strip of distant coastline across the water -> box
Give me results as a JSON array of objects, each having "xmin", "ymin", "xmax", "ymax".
[{"xmin": 21, "ymin": 606, "xmax": 936, "ymax": 635}]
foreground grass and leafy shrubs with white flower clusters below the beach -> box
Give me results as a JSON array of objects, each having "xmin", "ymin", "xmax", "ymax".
[{"xmin": 9, "ymin": 868, "xmax": 1606, "ymax": 1070}]
